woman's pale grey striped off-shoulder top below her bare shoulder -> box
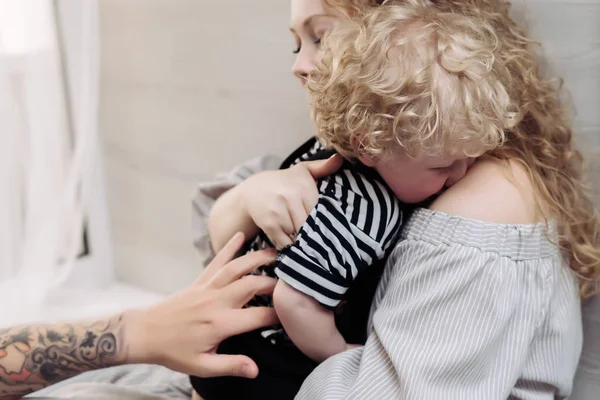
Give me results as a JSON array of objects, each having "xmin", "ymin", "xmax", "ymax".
[{"xmin": 297, "ymin": 209, "xmax": 582, "ymax": 400}]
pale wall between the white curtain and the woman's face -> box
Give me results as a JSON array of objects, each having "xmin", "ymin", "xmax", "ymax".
[{"xmin": 99, "ymin": 0, "xmax": 312, "ymax": 292}]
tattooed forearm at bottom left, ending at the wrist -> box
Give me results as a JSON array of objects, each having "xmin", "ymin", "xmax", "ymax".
[{"xmin": 0, "ymin": 315, "xmax": 127, "ymax": 399}]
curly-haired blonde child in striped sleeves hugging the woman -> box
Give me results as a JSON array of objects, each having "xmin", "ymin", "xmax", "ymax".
[{"xmin": 192, "ymin": 0, "xmax": 515, "ymax": 400}]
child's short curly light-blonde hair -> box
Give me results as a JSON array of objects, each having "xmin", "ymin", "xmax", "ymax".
[{"xmin": 309, "ymin": 0, "xmax": 518, "ymax": 159}]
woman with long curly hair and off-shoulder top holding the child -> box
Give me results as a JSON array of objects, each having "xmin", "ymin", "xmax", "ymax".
[{"xmin": 10, "ymin": 0, "xmax": 599, "ymax": 399}]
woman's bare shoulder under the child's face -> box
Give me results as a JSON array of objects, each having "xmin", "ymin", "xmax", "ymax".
[{"xmin": 430, "ymin": 157, "xmax": 540, "ymax": 224}]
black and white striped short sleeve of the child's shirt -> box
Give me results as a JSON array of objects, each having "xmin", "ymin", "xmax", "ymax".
[{"xmin": 275, "ymin": 169, "xmax": 402, "ymax": 309}]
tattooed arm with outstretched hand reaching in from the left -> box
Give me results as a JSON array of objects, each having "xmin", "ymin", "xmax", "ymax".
[{"xmin": 0, "ymin": 235, "xmax": 277, "ymax": 399}]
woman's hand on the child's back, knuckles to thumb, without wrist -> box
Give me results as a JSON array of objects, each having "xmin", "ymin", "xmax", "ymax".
[{"xmin": 238, "ymin": 156, "xmax": 343, "ymax": 249}]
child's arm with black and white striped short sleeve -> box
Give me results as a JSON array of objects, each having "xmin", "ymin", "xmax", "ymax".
[{"xmin": 273, "ymin": 169, "xmax": 402, "ymax": 362}]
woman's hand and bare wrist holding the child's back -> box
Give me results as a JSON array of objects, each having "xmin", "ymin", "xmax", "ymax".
[{"xmin": 209, "ymin": 155, "xmax": 343, "ymax": 251}]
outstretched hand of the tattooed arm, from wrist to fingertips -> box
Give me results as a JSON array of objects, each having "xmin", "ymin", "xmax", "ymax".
[{"xmin": 125, "ymin": 233, "xmax": 278, "ymax": 378}]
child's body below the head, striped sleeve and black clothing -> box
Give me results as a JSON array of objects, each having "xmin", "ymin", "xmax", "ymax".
[{"xmin": 191, "ymin": 138, "xmax": 407, "ymax": 400}]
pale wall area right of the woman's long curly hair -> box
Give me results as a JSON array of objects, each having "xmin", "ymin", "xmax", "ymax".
[{"xmin": 514, "ymin": 0, "xmax": 600, "ymax": 198}]
